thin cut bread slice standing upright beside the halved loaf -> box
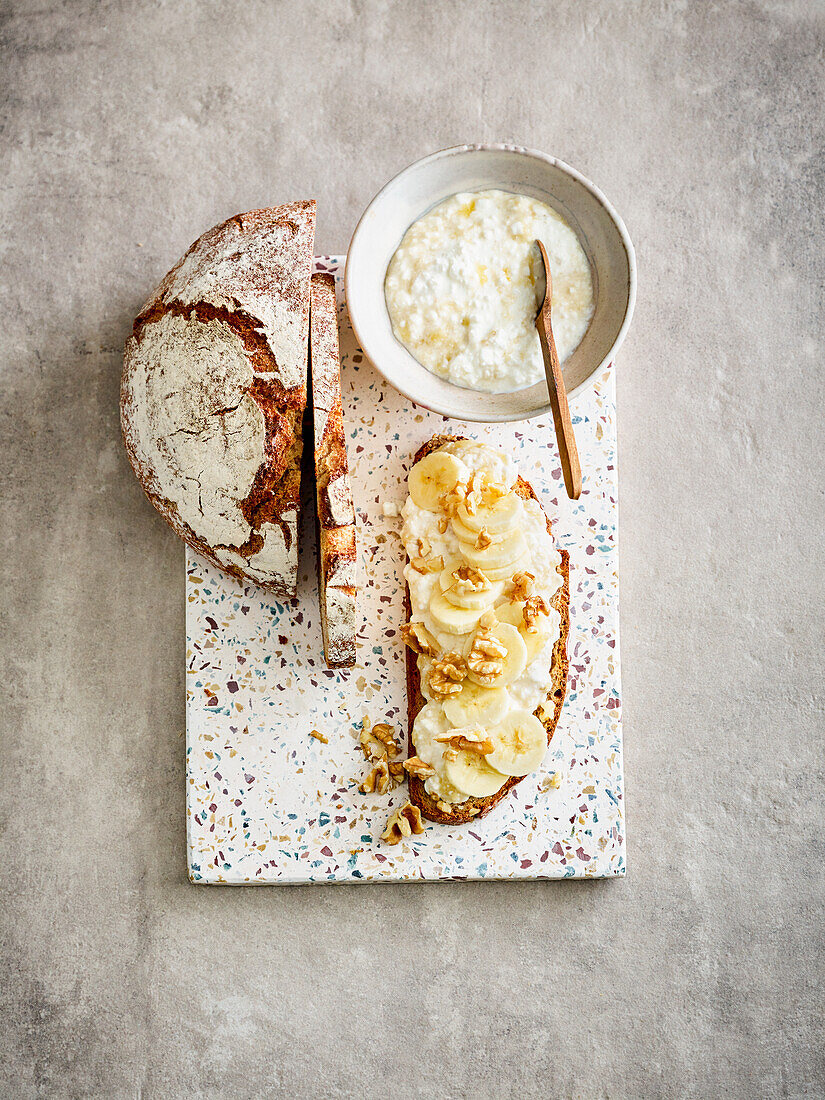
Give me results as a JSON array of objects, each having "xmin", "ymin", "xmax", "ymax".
[{"xmin": 310, "ymin": 272, "xmax": 358, "ymax": 668}]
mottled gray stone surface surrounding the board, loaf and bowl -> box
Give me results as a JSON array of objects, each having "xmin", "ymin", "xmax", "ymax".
[{"xmin": 0, "ymin": 0, "xmax": 825, "ymax": 1098}]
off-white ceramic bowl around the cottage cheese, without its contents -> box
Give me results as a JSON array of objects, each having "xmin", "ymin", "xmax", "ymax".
[{"xmin": 345, "ymin": 145, "xmax": 636, "ymax": 422}]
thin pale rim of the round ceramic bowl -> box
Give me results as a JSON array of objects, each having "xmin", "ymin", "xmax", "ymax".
[{"xmin": 344, "ymin": 142, "xmax": 636, "ymax": 424}]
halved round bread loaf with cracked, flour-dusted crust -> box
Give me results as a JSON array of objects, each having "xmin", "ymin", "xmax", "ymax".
[{"xmin": 120, "ymin": 201, "xmax": 316, "ymax": 597}]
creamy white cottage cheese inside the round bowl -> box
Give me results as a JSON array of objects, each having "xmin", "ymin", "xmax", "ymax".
[{"xmin": 384, "ymin": 190, "xmax": 593, "ymax": 393}]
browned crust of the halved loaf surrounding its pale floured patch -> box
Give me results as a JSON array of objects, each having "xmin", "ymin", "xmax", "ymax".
[{"xmin": 120, "ymin": 200, "xmax": 316, "ymax": 598}]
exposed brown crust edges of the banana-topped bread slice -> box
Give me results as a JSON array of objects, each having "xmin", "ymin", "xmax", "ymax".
[{"xmin": 406, "ymin": 436, "xmax": 570, "ymax": 825}]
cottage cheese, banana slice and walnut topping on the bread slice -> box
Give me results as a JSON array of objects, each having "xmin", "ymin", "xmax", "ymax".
[{"xmin": 402, "ymin": 440, "xmax": 563, "ymax": 804}]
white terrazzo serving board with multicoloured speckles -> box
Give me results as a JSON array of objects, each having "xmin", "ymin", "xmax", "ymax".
[{"xmin": 186, "ymin": 256, "xmax": 625, "ymax": 884}]
